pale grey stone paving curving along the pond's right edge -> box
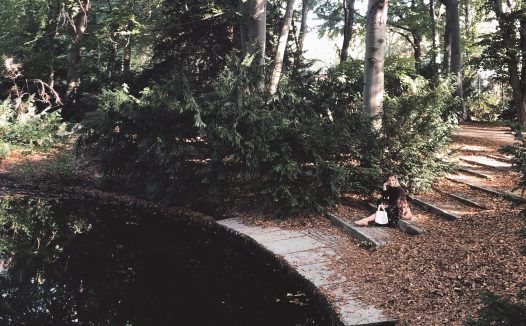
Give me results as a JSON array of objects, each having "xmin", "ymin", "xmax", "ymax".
[{"xmin": 217, "ymin": 217, "xmax": 398, "ymax": 326}]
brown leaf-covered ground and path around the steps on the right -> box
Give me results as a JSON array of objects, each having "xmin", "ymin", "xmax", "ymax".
[{"xmin": 326, "ymin": 121, "xmax": 526, "ymax": 326}]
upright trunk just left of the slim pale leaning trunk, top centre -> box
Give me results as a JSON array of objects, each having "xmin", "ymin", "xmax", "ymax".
[{"xmin": 247, "ymin": 0, "xmax": 267, "ymax": 90}]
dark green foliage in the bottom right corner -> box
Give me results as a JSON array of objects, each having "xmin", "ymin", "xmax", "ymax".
[{"xmin": 466, "ymin": 292, "xmax": 526, "ymax": 326}]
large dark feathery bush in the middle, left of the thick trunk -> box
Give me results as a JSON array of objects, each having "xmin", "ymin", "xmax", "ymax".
[{"xmin": 206, "ymin": 55, "xmax": 382, "ymax": 216}]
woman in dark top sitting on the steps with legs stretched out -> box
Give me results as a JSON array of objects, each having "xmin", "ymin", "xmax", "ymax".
[{"xmin": 354, "ymin": 175, "xmax": 413, "ymax": 226}]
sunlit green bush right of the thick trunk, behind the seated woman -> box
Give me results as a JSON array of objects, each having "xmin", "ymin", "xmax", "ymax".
[{"xmin": 382, "ymin": 77, "xmax": 455, "ymax": 192}]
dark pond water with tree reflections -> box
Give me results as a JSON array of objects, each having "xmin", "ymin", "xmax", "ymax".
[{"xmin": 0, "ymin": 197, "xmax": 327, "ymax": 326}]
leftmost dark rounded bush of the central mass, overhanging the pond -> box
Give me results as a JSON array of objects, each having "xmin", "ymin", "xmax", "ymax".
[{"xmin": 80, "ymin": 80, "xmax": 204, "ymax": 198}]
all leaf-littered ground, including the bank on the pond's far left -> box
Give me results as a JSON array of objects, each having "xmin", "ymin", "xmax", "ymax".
[{"xmin": 0, "ymin": 124, "xmax": 526, "ymax": 325}]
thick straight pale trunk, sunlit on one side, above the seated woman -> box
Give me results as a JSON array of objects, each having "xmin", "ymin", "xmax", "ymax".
[{"xmin": 363, "ymin": 0, "xmax": 388, "ymax": 116}]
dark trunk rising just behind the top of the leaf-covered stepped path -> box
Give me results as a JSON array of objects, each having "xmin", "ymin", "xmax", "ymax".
[{"xmin": 447, "ymin": 0, "xmax": 467, "ymax": 120}]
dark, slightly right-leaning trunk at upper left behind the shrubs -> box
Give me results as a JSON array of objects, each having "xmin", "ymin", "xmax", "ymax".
[{"xmin": 66, "ymin": 0, "xmax": 91, "ymax": 100}]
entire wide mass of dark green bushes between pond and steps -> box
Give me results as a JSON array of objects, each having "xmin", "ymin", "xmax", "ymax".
[{"xmin": 80, "ymin": 57, "xmax": 460, "ymax": 216}]
